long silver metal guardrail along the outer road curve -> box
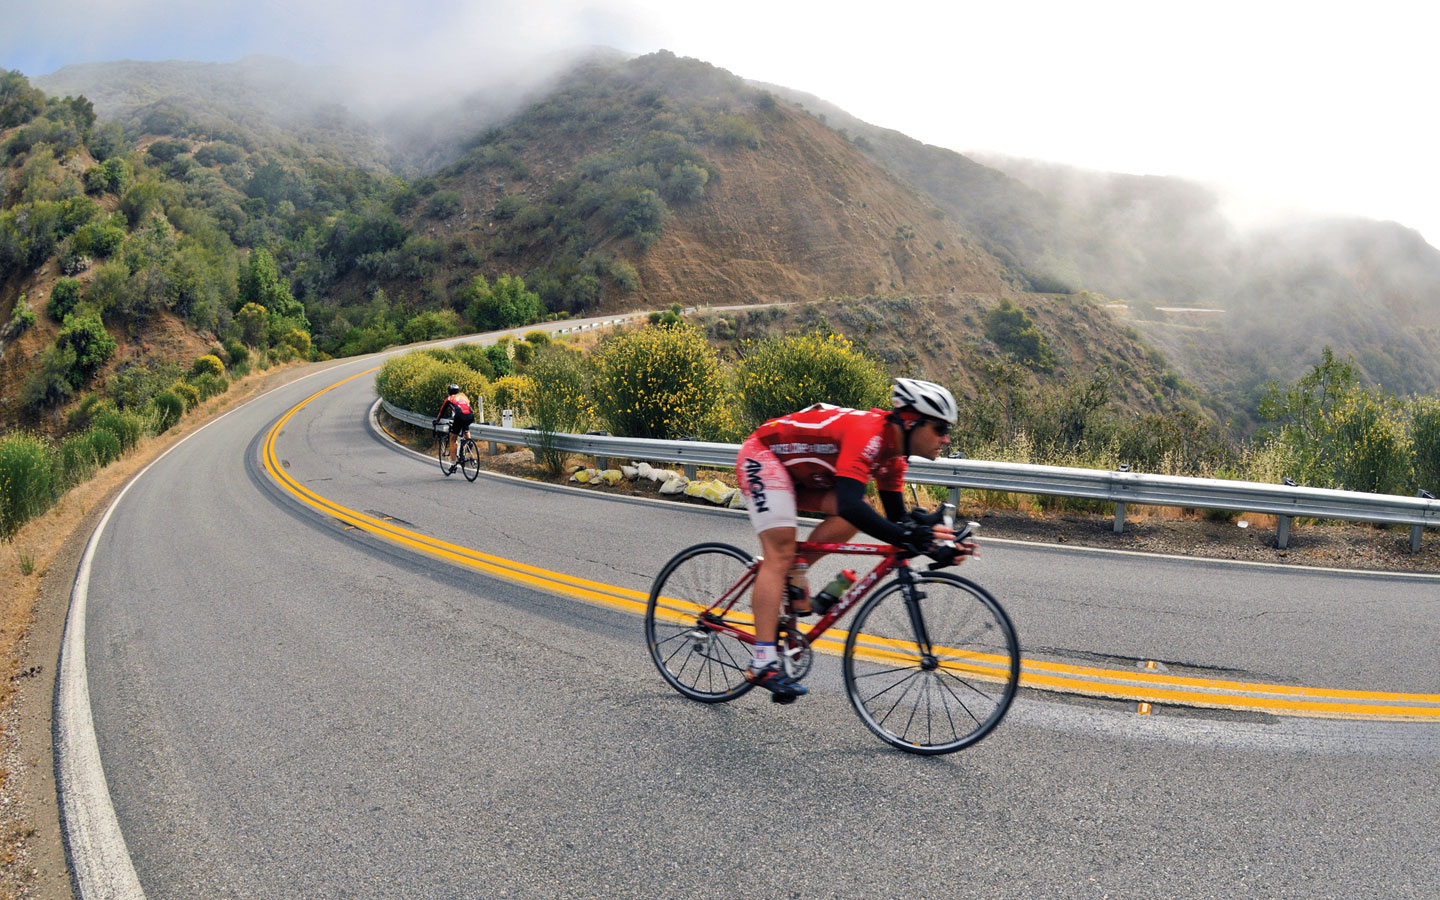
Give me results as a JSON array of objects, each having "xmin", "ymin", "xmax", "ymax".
[{"xmin": 382, "ymin": 400, "xmax": 1440, "ymax": 550}]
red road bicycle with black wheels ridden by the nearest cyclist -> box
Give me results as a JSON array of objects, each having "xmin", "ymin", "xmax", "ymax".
[{"xmin": 645, "ymin": 504, "xmax": 1020, "ymax": 755}]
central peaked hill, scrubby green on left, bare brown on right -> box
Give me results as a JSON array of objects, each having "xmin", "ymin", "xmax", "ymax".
[{"xmin": 406, "ymin": 53, "xmax": 1020, "ymax": 311}]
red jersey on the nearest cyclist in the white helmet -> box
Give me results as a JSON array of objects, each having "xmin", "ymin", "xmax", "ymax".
[{"xmin": 753, "ymin": 403, "xmax": 906, "ymax": 491}]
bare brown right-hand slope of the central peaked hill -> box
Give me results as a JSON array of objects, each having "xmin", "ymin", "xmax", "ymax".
[{"xmin": 634, "ymin": 108, "xmax": 1009, "ymax": 305}]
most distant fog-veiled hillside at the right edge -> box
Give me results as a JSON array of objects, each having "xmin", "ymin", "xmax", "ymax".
[{"xmin": 961, "ymin": 158, "xmax": 1440, "ymax": 428}]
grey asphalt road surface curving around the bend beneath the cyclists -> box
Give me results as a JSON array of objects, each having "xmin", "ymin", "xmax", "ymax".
[{"xmin": 75, "ymin": 344, "xmax": 1440, "ymax": 899}]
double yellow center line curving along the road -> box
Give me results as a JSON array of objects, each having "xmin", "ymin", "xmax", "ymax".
[{"xmin": 262, "ymin": 369, "xmax": 1440, "ymax": 721}]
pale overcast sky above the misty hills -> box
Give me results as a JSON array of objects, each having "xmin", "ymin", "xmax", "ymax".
[{"xmin": 0, "ymin": 0, "xmax": 1440, "ymax": 243}]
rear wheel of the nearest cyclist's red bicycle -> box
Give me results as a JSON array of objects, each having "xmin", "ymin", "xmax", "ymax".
[{"xmin": 645, "ymin": 543, "xmax": 756, "ymax": 703}]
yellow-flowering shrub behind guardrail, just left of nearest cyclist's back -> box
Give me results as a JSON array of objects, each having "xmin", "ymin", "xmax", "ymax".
[{"xmin": 595, "ymin": 325, "xmax": 729, "ymax": 441}]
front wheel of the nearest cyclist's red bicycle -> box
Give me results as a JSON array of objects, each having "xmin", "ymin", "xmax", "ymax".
[{"xmin": 842, "ymin": 572, "xmax": 1020, "ymax": 755}]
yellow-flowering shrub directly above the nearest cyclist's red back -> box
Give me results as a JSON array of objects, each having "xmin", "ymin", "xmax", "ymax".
[{"xmin": 734, "ymin": 331, "xmax": 890, "ymax": 428}]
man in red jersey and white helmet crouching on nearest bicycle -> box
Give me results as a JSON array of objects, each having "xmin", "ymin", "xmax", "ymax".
[{"xmin": 736, "ymin": 379, "xmax": 958, "ymax": 701}]
